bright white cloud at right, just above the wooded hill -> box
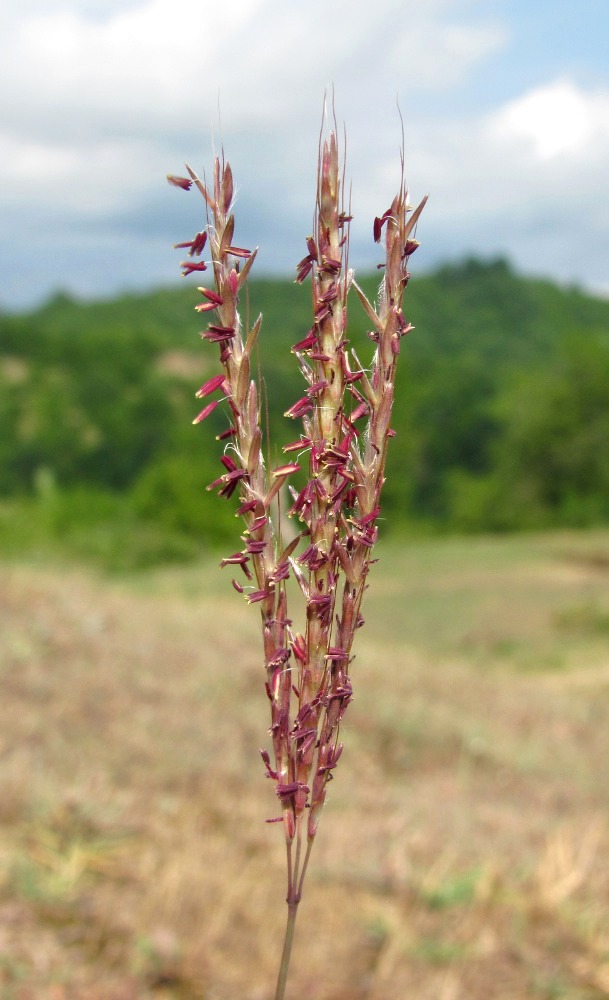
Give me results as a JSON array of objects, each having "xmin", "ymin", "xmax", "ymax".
[{"xmin": 388, "ymin": 79, "xmax": 609, "ymax": 219}]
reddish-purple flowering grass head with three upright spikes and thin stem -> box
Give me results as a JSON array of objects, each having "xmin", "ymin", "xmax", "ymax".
[{"xmin": 169, "ymin": 119, "xmax": 425, "ymax": 1000}]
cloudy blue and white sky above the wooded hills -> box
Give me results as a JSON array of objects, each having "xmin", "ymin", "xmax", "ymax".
[{"xmin": 0, "ymin": 0, "xmax": 609, "ymax": 309}]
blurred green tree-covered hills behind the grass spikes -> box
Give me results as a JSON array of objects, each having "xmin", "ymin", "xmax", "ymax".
[{"xmin": 0, "ymin": 260, "xmax": 609, "ymax": 568}]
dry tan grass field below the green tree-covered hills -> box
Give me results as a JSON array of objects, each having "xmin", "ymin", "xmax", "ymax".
[{"xmin": 0, "ymin": 532, "xmax": 609, "ymax": 1000}]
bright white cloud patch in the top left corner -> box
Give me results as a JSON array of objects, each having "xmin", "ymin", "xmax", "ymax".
[{"xmin": 0, "ymin": 0, "xmax": 262, "ymax": 137}]
